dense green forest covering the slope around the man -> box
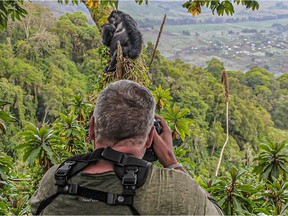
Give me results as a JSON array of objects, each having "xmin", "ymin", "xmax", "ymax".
[{"xmin": 0, "ymin": 3, "xmax": 288, "ymax": 215}]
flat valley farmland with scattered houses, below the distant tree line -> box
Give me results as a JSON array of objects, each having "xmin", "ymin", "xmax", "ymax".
[{"xmin": 142, "ymin": 19, "xmax": 288, "ymax": 75}]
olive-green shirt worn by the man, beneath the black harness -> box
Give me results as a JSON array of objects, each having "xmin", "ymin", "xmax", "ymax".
[{"xmin": 31, "ymin": 166, "xmax": 222, "ymax": 215}]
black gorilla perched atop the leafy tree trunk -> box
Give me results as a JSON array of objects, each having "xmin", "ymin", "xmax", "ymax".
[{"xmin": 101, "ymin": 11, "xmax": 143, "ymax": 72}]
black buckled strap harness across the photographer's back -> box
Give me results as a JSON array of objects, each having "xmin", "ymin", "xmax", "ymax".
[{"xmin": 36, "ymin": 147, "xmax": 152, "ymax": 215}]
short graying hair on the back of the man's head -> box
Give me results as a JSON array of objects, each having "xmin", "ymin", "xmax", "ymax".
[{"xmin": 93, "ymin": 80, "xmax": 155, "ymax": 142}]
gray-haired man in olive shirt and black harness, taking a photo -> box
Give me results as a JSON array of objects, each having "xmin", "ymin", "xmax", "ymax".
[{"xmin": 31, "ymin": 80, "xmax": 222, "ymax": 215}]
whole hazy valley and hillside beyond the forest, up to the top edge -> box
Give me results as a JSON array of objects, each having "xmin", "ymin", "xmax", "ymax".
[{"xmin": 41, "ymin": 1, "xmax": 288, "ymax": 75}]
